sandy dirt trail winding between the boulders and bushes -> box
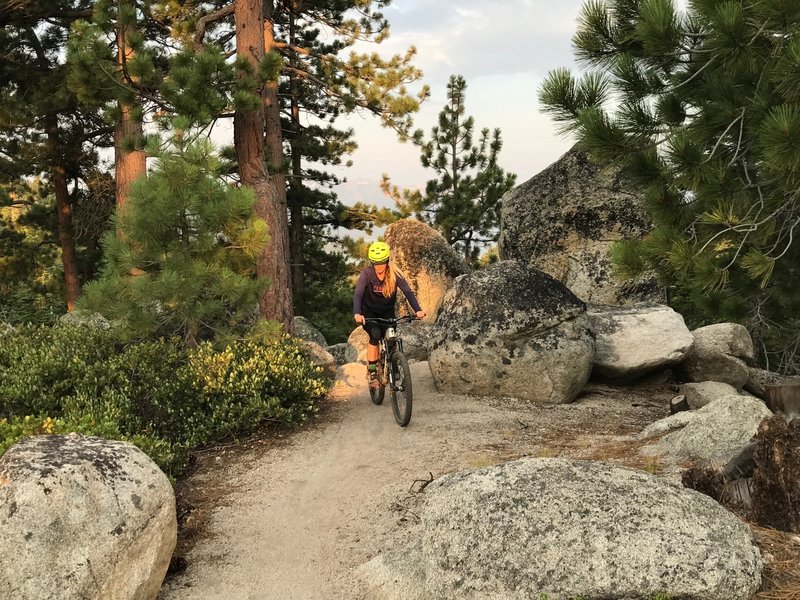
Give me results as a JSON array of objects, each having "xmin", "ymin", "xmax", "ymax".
[{"xmin": 159, "ymin": 363, "xmax": 673, "ymax": 600}]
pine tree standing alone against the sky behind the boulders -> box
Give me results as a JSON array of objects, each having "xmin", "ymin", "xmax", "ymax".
[{"xmin": 381, "ymin": 75, "xmax": 517, "ymax": 263}]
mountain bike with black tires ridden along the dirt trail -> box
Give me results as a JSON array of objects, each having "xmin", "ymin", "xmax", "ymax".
[{"xmin": 365, "ymin": 316, "xmax": 416, "ymax": 427}]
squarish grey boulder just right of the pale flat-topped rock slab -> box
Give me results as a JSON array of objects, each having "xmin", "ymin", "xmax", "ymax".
[{"xmin": 681, "ymin": 323, "xmax": 755, "ymax": 389}]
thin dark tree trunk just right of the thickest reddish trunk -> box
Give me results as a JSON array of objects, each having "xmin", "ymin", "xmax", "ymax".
[{"xmin": 288, "ymin": 12, "xmax": 305, "ymax": 298}]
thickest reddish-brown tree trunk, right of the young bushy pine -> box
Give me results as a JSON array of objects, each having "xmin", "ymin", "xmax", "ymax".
[{"xmin": 233, "ymin": 0, "xmax": 293, "ymax": 331}]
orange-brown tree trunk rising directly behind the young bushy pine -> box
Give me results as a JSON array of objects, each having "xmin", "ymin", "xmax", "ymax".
[{"xmin": 114, "ymin": 0, "xmax": 147, "ymax": 208}]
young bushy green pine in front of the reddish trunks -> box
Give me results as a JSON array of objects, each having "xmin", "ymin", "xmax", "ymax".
[{"xmin": 81, "ymin": 127, "xmax": 267, "ymax": 345}]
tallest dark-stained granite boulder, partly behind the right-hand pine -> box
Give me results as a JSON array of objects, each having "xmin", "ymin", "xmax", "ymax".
[{"xmin": 499, "ymin": 147, "xmax": 664, "ymax": 304}]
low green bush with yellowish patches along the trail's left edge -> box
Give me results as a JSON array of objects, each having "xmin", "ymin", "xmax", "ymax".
[{"xmin": 0, "ymin": 325, "xmax": 329, "ymax": 475}]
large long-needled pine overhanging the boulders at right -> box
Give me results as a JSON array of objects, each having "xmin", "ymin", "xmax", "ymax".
[{"xmin": 540, "ymin": 0, "xmax": 800, "ymax": 371}]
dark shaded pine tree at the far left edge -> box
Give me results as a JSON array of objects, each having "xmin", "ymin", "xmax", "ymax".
[{"xmin": 0, "ymin": 0, "xmax": 108, "ymax": 310}]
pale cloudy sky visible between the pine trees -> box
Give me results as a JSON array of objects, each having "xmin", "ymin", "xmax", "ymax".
[{"xmin": 324, "ymin": 0, "xmax": 584, "ymax": 212}]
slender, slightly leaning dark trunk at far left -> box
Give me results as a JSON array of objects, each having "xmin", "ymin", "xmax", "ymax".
[{"xmin": 46, "ymin": 115, "xmax": 81, "ymax": 312}]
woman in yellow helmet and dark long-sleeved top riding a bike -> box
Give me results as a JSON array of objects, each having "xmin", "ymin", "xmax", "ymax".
[{"xmin": 353, "ymin": 242, "xmax": 425, "ymax": 388}]
